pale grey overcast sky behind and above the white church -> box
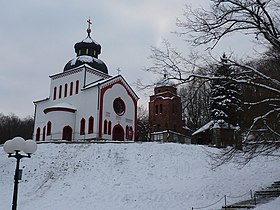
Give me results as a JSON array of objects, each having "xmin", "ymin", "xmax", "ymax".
[{"xmin": 0, "ymin": 0, "xmax": 256, "ymax": 117}]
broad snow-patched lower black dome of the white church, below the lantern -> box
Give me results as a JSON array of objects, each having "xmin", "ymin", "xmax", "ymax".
[{"xmin": 63, "ymin": 55, "xmax": 108, "ymax": 74}]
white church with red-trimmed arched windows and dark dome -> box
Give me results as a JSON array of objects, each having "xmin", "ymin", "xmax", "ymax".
[{"xmin": 34, "ymin": 20, "xmax": 139, "ymax": 141}]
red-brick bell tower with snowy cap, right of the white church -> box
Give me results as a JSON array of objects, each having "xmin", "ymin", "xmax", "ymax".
[{"xmin": 149, "ymin": 76, "xmax": 189, "ymax": 141}]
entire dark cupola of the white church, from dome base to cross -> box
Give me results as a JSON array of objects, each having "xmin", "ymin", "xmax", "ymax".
[{"xmin": 64, "ymin": 19, "xmax": 108, "ymax": 74}]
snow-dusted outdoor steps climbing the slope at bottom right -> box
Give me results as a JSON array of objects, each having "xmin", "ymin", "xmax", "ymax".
[{"xmin": 222, "ymin": 181, "xmax": 280, "ymax": 210}]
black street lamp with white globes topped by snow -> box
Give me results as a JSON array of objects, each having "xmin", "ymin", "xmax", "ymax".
[{"xmin": 4, "ymin": 137, "xmax": 37, "ymax": 210}]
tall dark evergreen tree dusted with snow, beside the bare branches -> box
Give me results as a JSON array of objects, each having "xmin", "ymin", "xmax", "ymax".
[{"xmin": 210, "ymin": 54, "xmax": 242, "ymax": 127}]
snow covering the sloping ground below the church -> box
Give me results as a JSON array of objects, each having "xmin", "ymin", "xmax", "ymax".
[{"xmin": 0, "ymin": 143, "xmax": 280, "ymax": 210}]
